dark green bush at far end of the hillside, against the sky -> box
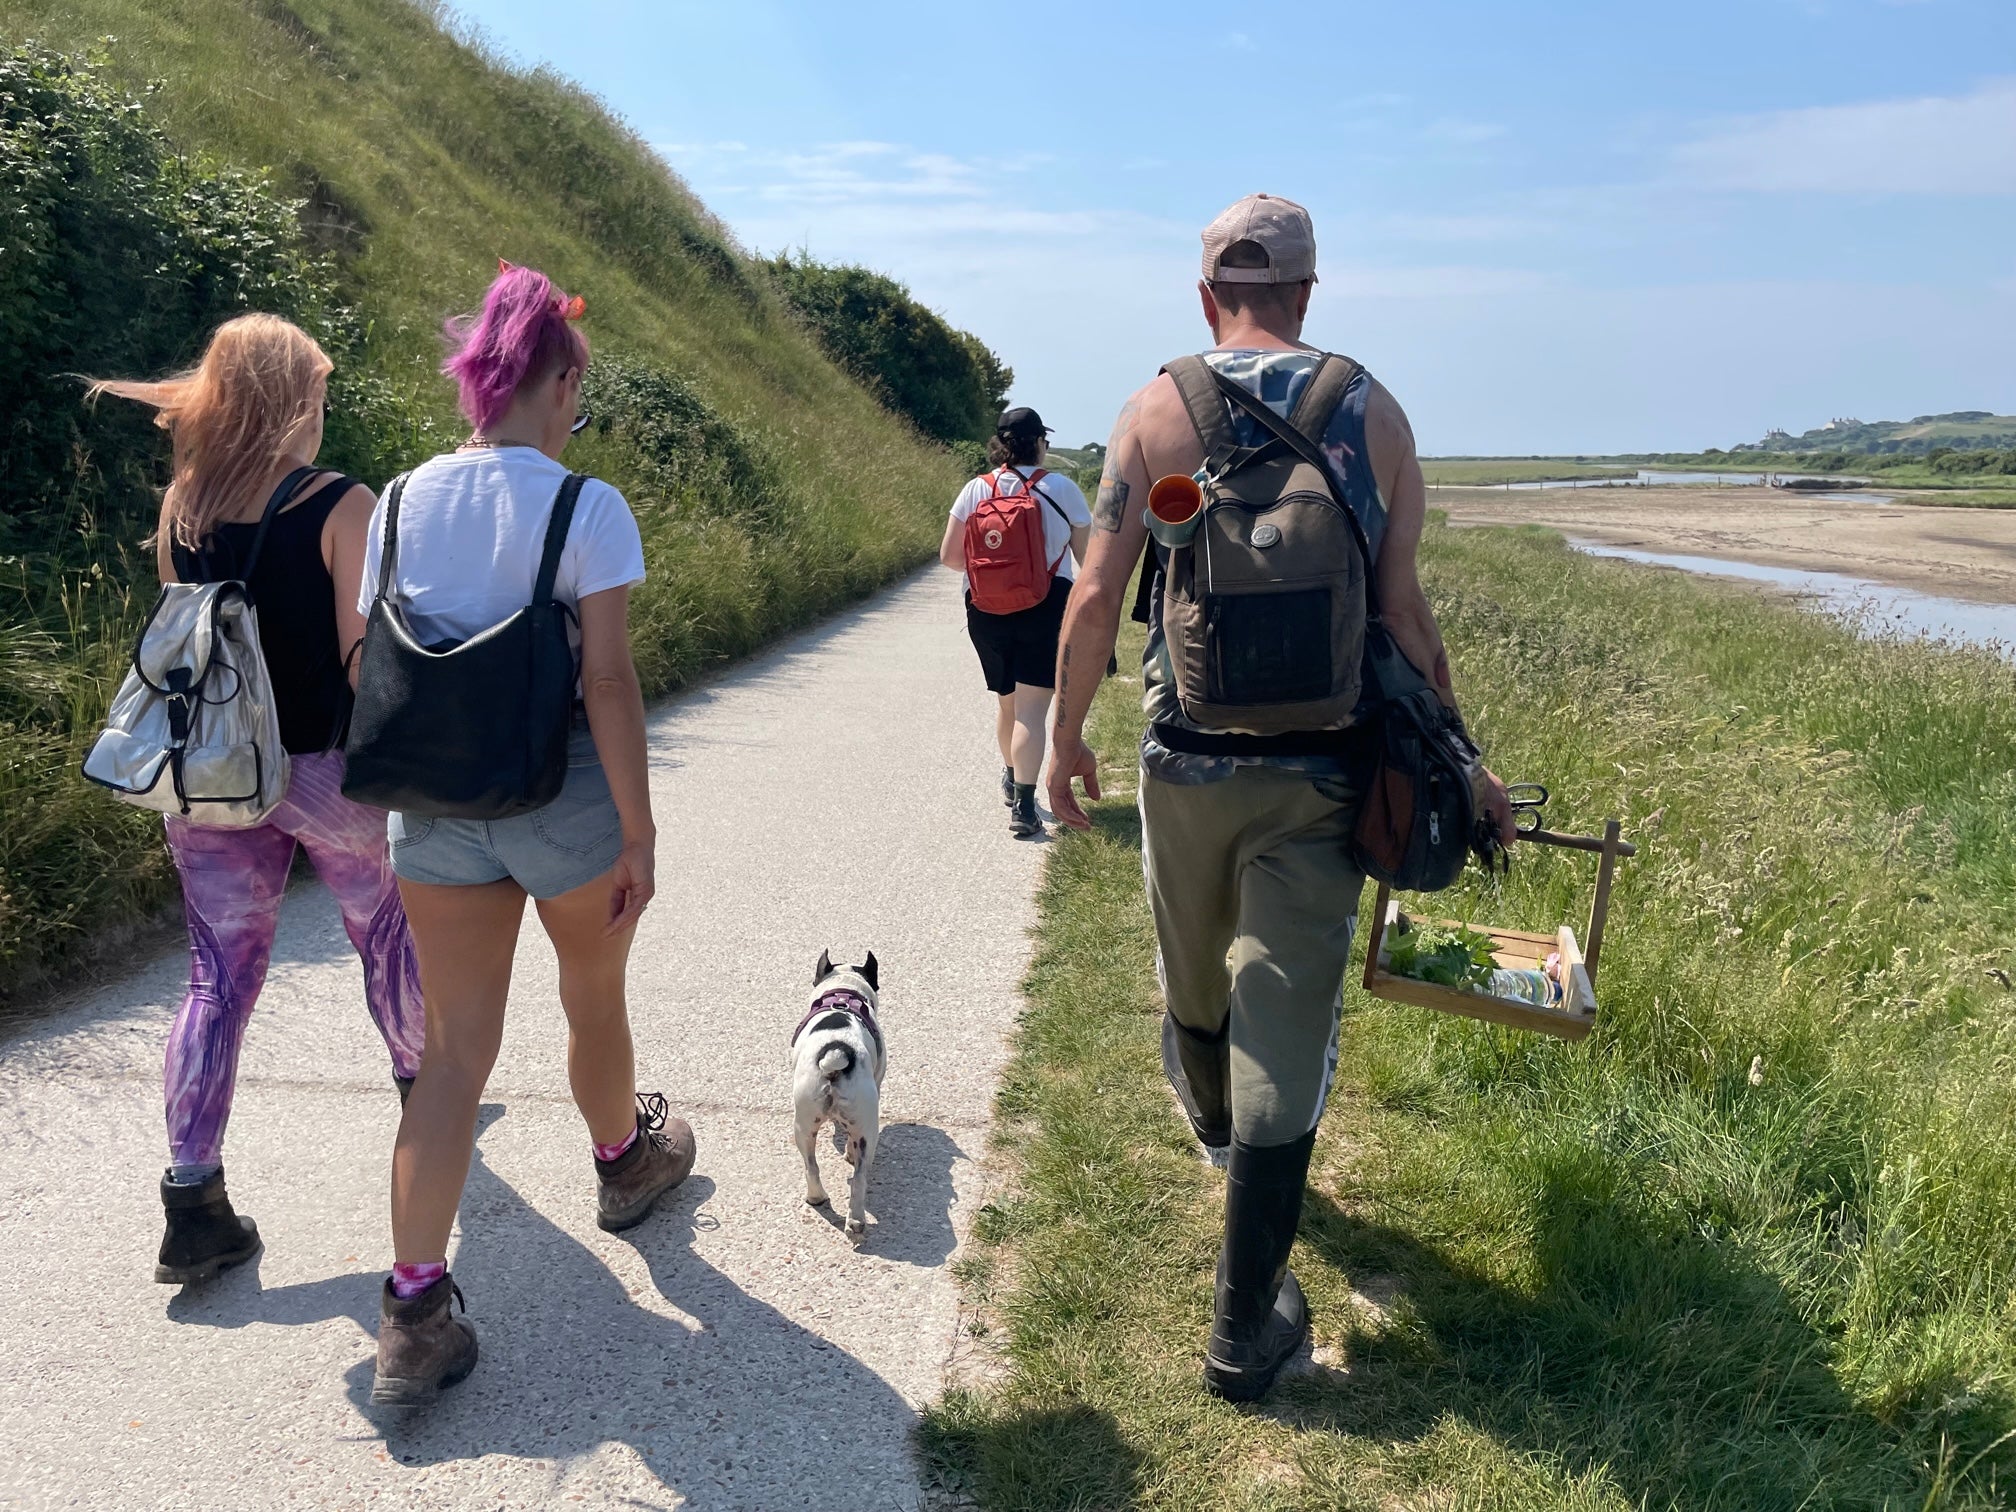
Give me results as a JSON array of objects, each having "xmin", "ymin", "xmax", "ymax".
[{"xmin": 766, "ymin": 254, "xmax": 1014, "ymax": 442}]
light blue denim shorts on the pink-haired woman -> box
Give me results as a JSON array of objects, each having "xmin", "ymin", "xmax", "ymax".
[{"xmin": 385, "ymin": 720, "xmax": 623, "ymax": 897}]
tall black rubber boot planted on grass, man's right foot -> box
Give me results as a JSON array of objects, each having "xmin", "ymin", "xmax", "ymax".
[{"xmin": 1204, "ymin": 1129, "xmax": 1316, "ymax": 1401}]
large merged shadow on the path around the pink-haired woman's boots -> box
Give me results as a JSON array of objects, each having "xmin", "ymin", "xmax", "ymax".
[{"xmin": 171, "ymin": 1103, "xmax": 935, "ymax": 1512}]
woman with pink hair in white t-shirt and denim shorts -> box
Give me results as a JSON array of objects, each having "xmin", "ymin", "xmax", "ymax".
[{"xmin": 357, "ymin": 264, "xmax": 694, "ymax": 1405}]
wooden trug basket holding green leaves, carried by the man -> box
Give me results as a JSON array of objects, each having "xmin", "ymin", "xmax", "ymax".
[{"xmin": 1365, "ymin": 818, "xmax": 1637, "ymax": 1040}]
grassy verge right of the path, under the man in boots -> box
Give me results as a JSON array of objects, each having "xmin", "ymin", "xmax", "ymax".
[{"xmin": 923, "ymin": 528, "xmax": 2016, "ymax": 1512}]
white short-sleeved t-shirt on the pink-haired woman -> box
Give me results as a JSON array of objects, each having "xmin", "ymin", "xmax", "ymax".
[{"xmin": 357, "ymin": 446, "xmax": 643, "ymax": 641}]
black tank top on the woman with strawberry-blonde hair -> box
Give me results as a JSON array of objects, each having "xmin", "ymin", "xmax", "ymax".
[{"xmin": 173, "ymin": 478, "xmax": 357, "ymax": 756}]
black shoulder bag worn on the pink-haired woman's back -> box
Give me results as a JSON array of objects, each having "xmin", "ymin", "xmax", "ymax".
[{"xmin": 343, "ymin": 474, "xmax": 587, "ymax": 818}]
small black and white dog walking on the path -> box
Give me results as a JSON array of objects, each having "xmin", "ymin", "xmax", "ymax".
[{"xmin": 790, "ymin": 952, "xmax": 889, "ymax": 1238}]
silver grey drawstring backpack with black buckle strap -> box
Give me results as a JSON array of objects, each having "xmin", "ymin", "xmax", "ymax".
[{"xmin": 85, "ymin": 468, "xmax": 300, "ymax": 829}]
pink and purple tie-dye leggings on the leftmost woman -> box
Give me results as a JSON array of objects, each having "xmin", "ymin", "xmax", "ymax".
[{"xmin": 163, "ymin": 752, "xmax": 425, "ymax": 1165}]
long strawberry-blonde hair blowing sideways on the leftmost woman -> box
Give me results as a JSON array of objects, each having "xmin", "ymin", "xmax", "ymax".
[{"xmin": 89, "ymin": 314, "xmax": 335, "ymax": 548}]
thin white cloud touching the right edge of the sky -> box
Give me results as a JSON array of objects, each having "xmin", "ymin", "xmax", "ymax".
[{"xmin": 1673, "ymin": 77, "xmax": 2016, "ymax": 194}]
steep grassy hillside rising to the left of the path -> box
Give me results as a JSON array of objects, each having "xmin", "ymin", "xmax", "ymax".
[{"xmin": 0, "ymin": 0, "xmax": 962, "ymax": 1008}]
